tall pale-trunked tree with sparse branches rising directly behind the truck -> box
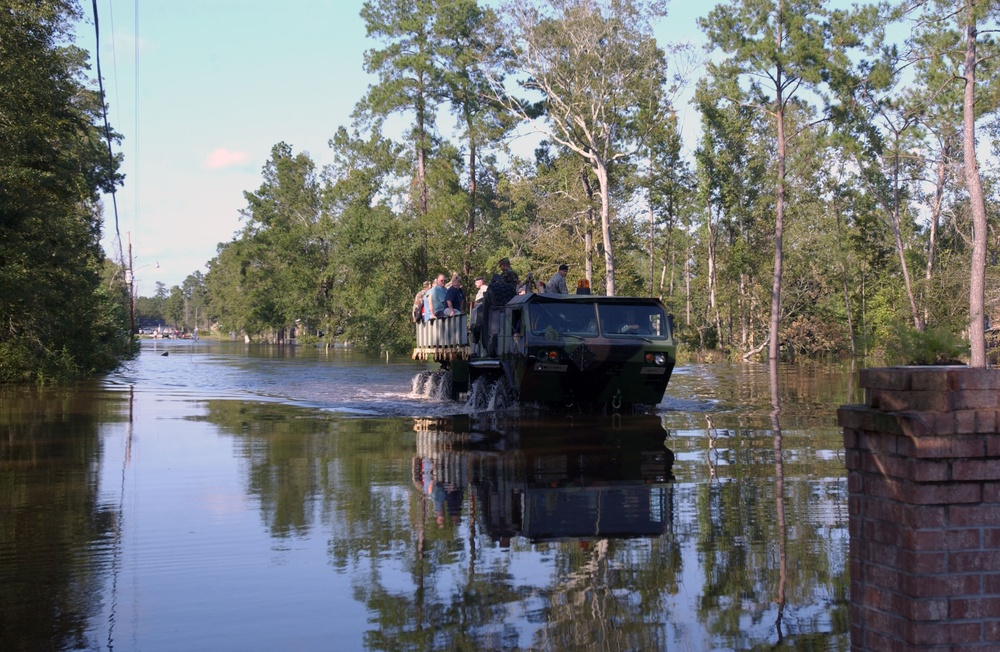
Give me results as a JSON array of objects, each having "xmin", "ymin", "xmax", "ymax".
[{"xmin": 494, "ymin": 0, "xmax": 666, "ymax": 295}]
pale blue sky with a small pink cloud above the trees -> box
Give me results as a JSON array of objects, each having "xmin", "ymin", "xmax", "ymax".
[{"xmin": 76, "ymin": 0, "xmax": 715, "ymax": 296}]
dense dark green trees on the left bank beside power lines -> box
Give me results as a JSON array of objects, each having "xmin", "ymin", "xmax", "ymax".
[{"xmin": 0, "ymin": 0, "xmax": 136, "ymax": 384}]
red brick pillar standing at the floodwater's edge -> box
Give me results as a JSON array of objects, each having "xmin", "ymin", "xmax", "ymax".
[{"xmin": 837, "ymin": 367, "xmax": 1000, "ymax": 652}]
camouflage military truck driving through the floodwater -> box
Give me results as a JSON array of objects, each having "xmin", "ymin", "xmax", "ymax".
[{"xmin": 413, "ymin": 293, "xmax": 676, "ymax": 409}]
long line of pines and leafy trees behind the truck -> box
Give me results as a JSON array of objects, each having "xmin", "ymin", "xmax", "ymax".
[{"xmin": 9, "ymin": 0, "xmax": 1000, "ymax": 374}]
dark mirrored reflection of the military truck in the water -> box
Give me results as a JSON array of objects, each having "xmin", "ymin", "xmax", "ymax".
[{"xmin": 412, "ymin": 415, "xmax": 674, "ymax": 546}]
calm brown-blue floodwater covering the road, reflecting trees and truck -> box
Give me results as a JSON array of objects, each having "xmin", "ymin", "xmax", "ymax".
[{"xmin": 0, "ymin": 340, "xmax": 859, "ymax": 652}]
